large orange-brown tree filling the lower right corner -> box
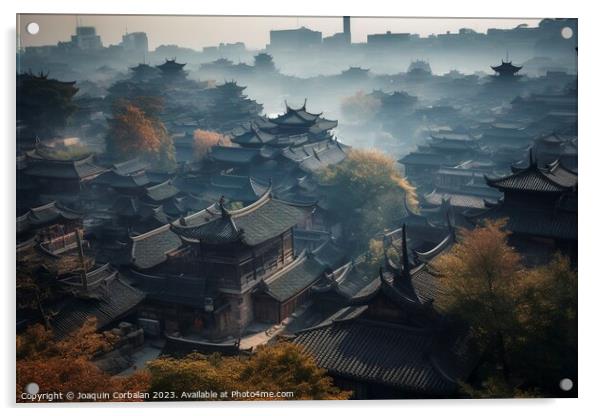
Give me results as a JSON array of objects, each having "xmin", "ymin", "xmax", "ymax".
[{"xmin": 433, "ymin": 221, "xmax": 577, "ymax": 397}]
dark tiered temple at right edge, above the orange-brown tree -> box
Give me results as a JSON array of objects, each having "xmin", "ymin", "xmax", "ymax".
[{"xmin": 467, "ymin": 154, "xmax": 577, "ymax": 264}]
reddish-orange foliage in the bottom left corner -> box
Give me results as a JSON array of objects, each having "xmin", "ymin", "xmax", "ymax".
[{"xmin": 16, "ymin": 319, "xmax": 148, "ymax": 401}]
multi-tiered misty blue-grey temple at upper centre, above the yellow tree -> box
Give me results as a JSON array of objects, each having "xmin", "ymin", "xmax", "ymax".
[{"xmin": 204, "ymin": 104, "xmax": 349, "ymax": 221}]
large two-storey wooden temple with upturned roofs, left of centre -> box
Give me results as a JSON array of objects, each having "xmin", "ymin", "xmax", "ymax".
[{"xmin": 130, "ymin": 188, "xmax": 329, "ymax": 341}]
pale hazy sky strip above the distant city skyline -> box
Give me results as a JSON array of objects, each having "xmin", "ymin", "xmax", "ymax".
[{"xmin": 17, "ymin": 14, "xmax": 540, "ymax": 50}]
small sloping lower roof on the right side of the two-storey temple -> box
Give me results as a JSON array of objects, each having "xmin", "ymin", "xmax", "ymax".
[{"xmin": 263, "ymin": 253, "xmax": 325, "ymax": 302}]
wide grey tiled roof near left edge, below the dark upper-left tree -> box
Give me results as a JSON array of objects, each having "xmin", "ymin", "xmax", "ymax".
[{"xmin": 25, "ymin": 150, "xmax": 105, "ymax": 180}]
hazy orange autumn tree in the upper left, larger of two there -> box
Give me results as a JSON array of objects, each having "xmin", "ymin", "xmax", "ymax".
[{"xmin": 107, "ymin": 97, "xmax": 175, "ymax": 170}]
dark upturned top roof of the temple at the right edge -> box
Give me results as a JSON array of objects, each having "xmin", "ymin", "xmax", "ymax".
[{"xmin": 485, "ymin": 158, "xmax": 577, "ymax": 193}]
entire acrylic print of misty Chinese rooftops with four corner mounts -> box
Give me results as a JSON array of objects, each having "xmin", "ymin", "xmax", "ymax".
[{"xmin": 16, "ymin": 15, "xmax": 578, "ymax": 403}]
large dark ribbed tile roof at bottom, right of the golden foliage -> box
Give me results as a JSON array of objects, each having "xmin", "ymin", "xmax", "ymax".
[{"xmin": 293, "ymin": 319, "xmax": 457, "ymax": 396}]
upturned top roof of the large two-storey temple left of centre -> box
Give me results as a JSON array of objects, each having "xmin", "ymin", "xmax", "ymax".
[{"xmin": 172, "ymin": 187, "xmax": 304, "ymax": 246}]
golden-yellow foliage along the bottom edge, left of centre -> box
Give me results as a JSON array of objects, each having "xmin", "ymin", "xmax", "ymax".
[{"xmin": 148, "ymin": 342, "xmax": 349, "ymax": 400}]
